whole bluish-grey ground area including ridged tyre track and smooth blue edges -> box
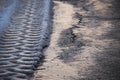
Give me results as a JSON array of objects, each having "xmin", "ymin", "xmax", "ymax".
[{"xmin": 0, "ymin": 0, "xmax": 51, "ymax": 80}]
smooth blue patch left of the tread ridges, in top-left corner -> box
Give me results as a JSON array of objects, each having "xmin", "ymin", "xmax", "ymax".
[{"xmin": 0, "ymin": 0, "xmax": 18, "ymax": 34}]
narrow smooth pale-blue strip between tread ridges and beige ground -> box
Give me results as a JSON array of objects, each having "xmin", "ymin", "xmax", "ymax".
[{"xmin": 39, "ymin": 0, "xmax": 52, "ymax": 47}]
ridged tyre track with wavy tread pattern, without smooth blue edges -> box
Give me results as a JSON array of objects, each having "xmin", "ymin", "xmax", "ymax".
[{"xmin": 0, "ymin": 0, "xmax": 49, "ymax": 80}]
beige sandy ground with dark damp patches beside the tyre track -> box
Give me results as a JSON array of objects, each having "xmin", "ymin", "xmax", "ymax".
[{"xmin": 32, "ymin": 0, "xmax": 120, "ymax": 80}]
